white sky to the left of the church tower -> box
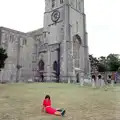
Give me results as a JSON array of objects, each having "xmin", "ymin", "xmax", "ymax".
[{"xmin": 0, "ymin": 0, "xmax": 44, "ymax": 32}]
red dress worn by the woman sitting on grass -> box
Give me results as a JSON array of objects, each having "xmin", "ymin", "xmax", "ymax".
[{"xmin": 43, "ymin": 99, "xmax": 57, "ymax": 114}]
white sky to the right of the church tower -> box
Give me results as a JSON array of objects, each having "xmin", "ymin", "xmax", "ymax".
[{"xmin": 85, "ymin": 0, "xmax": 120, "ymax": 57}]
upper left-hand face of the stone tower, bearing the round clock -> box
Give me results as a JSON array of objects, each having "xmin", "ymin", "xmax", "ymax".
[{"xmin": 44, "ymin": 0, "xmax": 65, "ymax": 44}]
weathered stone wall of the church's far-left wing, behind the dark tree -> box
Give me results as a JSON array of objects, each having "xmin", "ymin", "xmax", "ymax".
[{"xmin": 0, "ymin": 27, "xmax": 34, "ymax": 82}]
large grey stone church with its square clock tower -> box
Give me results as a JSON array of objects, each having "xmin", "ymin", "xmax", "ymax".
[{"xmin": 0, "ymin": 0, "xmax": 89, "ymax": 82}]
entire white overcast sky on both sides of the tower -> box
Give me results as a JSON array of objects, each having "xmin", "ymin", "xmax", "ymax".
[{"xmin": 0, "ymin": 0, "xmax": 120, "ymax": 57}]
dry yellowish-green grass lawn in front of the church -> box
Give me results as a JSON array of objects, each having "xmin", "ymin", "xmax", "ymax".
[{"xmin": 0, "ymin": 83, "xmax": 120, "ymax": 120}]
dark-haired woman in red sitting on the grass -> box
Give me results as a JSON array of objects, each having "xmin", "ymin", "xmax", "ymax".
[{"xmin": 42, "ymin": 95, "xmax": 65, "ymax": 116}]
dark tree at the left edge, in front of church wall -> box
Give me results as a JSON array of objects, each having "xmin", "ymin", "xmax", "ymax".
[{"xmin": 0, "ymin": 48, "xmax": 8, "ymax": 70}]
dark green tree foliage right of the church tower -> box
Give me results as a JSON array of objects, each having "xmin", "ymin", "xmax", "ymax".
[{"xmin": 89, "ymin": 54, "xmax": 120, "ymax": 72}]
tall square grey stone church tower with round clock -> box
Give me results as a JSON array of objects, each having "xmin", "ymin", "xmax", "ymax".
[{"xmin": 44, "ymin": 0, "xmax": 89, "ymax": 82}]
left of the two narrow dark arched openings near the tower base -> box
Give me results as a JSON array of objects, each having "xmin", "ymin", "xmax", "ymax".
[{"xmin": 38, "ymin": 60, "xmax": 45, "ymax": 82}]
